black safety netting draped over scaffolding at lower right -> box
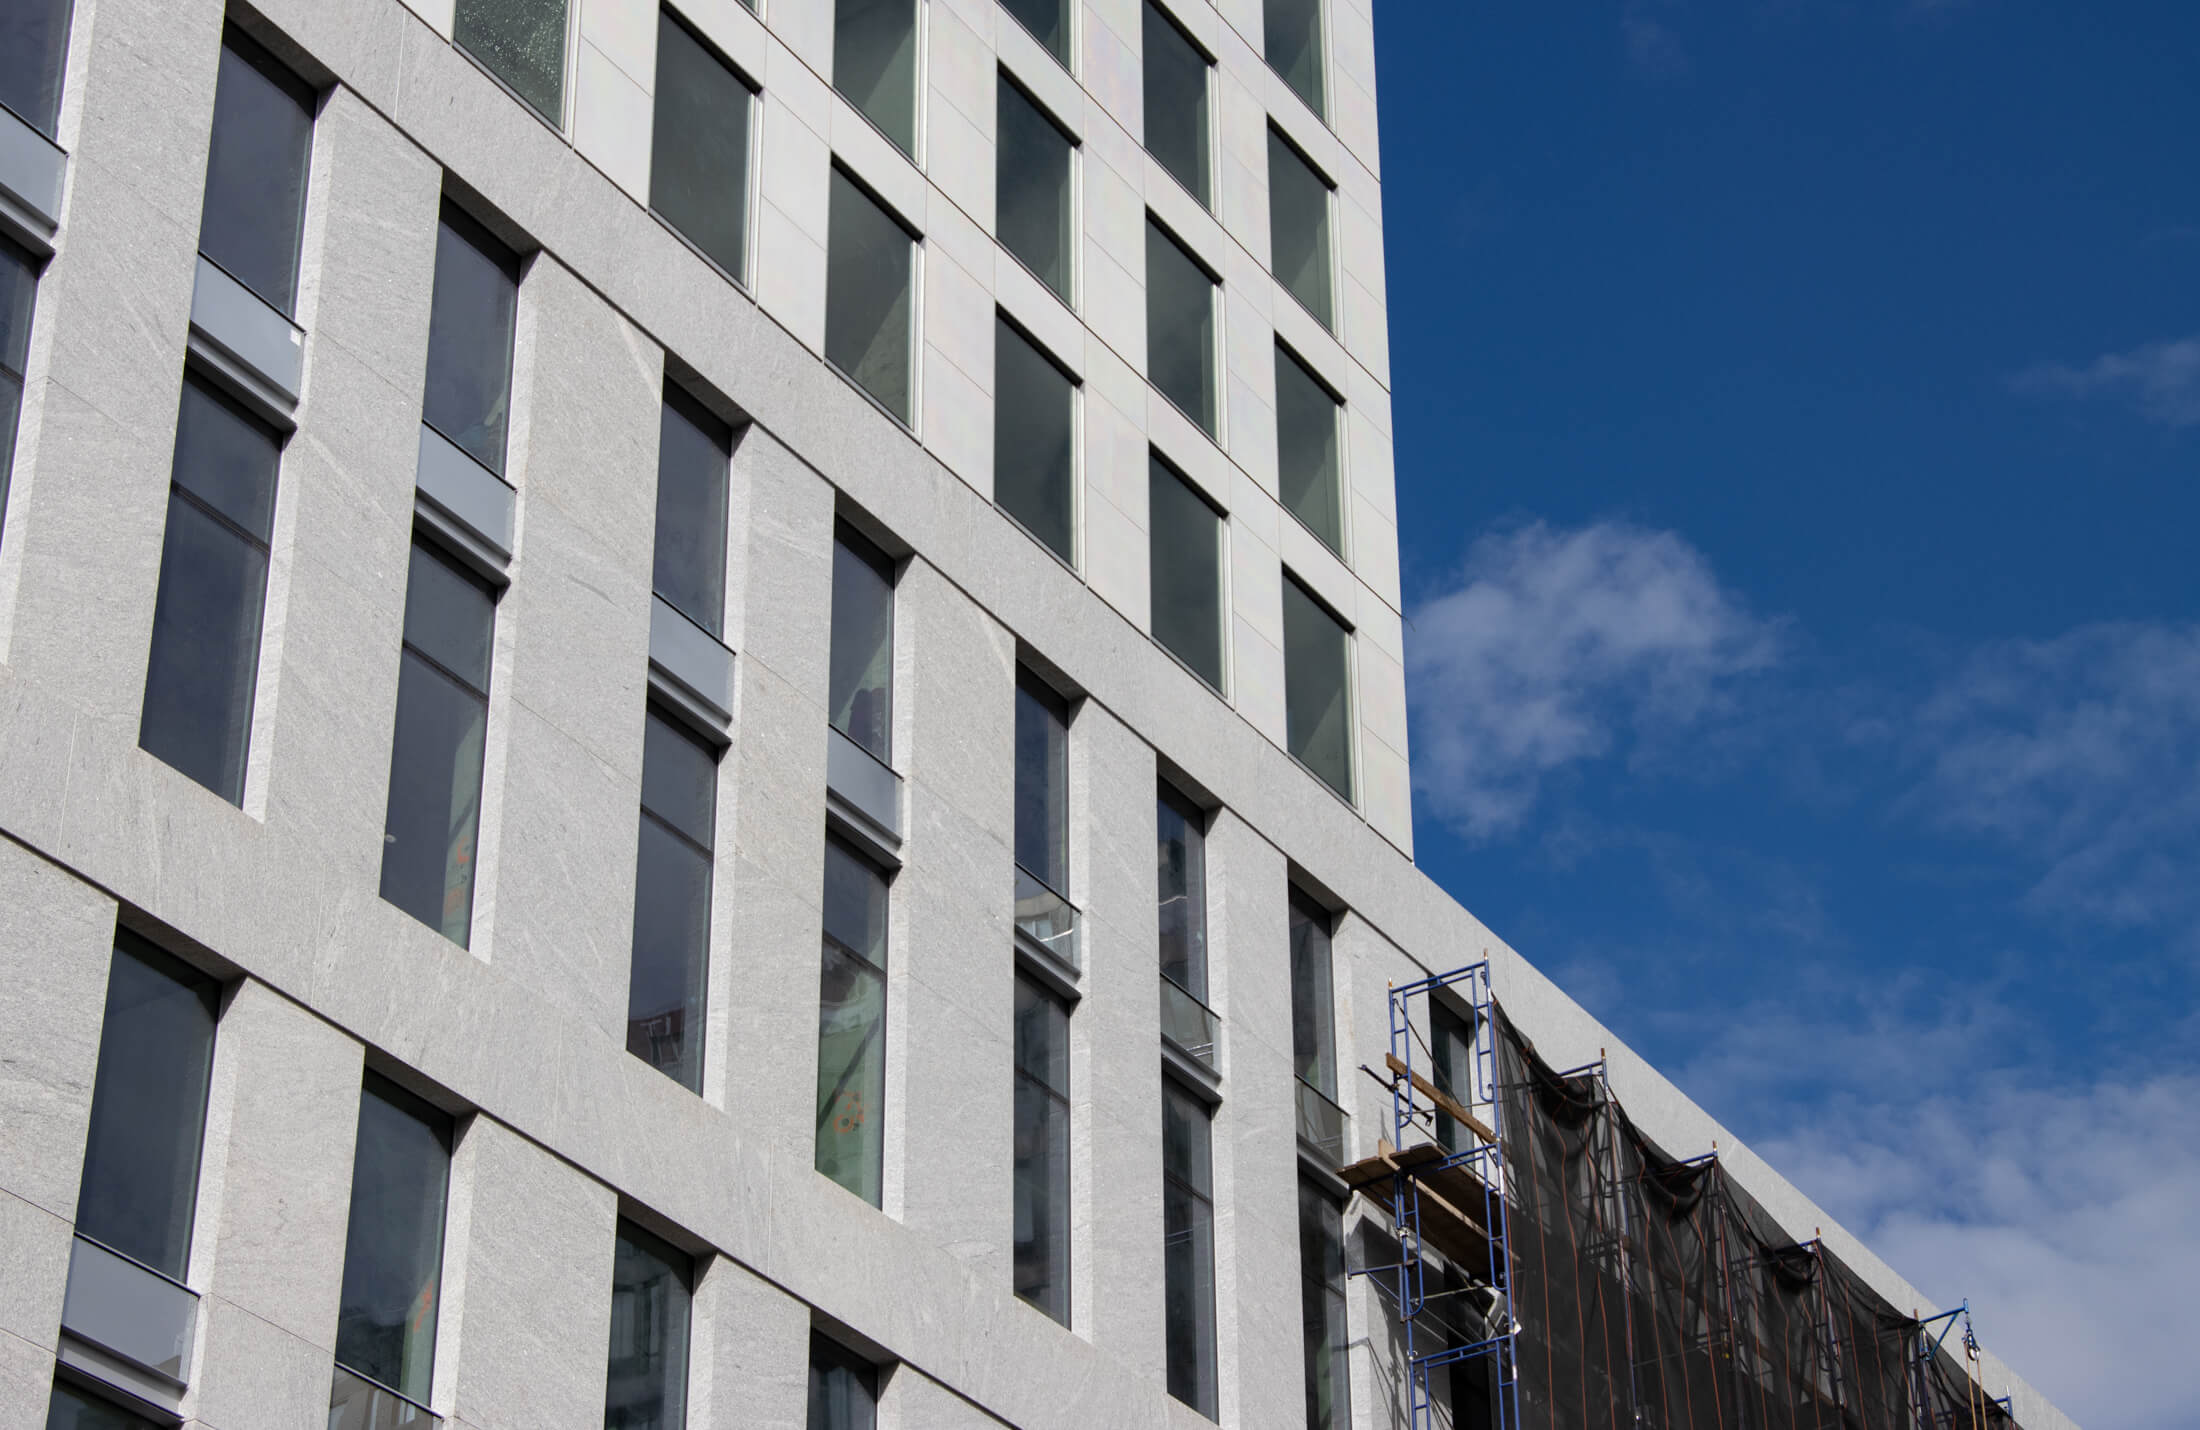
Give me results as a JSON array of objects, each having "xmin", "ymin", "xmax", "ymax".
[{"xmin": 1498, "ymin": 1012, "xmax": 2013, "ymax": 1430}]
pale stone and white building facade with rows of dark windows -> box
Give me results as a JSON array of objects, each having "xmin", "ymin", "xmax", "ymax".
[{"xmin": 0, "ymin": 0, "xmax": 2057, "ymax": 1430}]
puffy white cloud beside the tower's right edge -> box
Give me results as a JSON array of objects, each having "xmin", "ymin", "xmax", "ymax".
[{"xmin": 1406, "ymin": 521, "xmax": 1780, "ymax": 838}]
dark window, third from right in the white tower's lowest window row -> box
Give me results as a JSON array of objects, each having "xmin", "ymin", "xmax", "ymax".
[{"xmin": 992, "ymin": 315, "xmax": 1078, "ymax": 565}]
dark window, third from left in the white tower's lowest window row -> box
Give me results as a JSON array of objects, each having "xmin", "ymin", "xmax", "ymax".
[{"xmin": 825, "ymin": 168, "xmax": 917, "ymax": 427}]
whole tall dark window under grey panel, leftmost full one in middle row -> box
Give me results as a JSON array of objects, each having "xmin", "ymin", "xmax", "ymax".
[{"xmin": 139, "ymin": 376, "xmax": 282, "ymax": 805}]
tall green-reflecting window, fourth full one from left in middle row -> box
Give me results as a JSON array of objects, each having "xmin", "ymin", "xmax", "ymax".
[{"xmin": 816, "ymin": 838, "xmax": 887, "ymax": 1206}]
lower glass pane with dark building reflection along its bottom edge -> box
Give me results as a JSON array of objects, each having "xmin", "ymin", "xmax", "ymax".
[{"xmin": 627, "ymin": 814, "xmax": 711, "ymax": 1091}]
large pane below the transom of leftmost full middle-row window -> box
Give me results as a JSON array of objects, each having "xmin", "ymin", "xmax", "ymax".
[{"xmin": 139, "ymin": 493, "xmax": 268, "ymax": 803}]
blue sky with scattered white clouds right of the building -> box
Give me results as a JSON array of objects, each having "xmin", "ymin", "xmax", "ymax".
[{"xmin": 1375, "ymin": 0, "xmax": 2200, "ymax": 1430}]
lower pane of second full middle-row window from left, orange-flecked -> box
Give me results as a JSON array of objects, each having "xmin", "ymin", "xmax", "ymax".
[{"xmin": 383, "ymin": 651, "xmax": 488, "ymax": 948}]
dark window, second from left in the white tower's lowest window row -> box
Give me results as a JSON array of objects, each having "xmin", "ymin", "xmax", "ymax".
[{"xmin": 649, "ymin": 11, "xmax": 755, "ymax": 282}]
